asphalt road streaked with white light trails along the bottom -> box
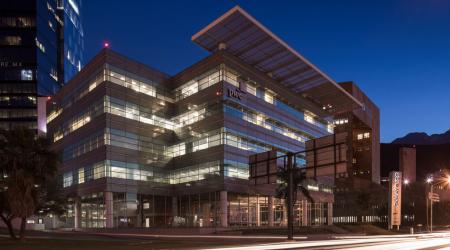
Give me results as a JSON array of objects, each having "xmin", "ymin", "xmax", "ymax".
[{"xmin": 0, "ymin": 231, "xmax": 450, "ymax": 250}]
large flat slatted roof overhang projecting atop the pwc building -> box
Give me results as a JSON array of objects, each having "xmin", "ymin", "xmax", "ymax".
[{"xmin": 192, "ymin": 6, "xmax": 363, "ymax": 114}]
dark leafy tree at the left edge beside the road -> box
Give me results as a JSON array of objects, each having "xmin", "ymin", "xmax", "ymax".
[{"xmin": 0, "ymin": 127, "xmax": 58, "ymax": 239}]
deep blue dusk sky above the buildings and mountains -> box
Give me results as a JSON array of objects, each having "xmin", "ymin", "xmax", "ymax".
[{"xmin": 82, "ymin": 0, "xmax": 450, "ymax": 142}]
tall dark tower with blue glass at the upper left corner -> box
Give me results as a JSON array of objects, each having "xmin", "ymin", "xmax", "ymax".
[{"xmin": 0, "ymin": 0, "xmax": 83, "ymax": 132}]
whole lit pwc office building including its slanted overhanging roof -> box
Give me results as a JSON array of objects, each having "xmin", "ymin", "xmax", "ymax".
[{"xmin": 47, "ymin": 7, "xmax": 362, "ymax": 228}]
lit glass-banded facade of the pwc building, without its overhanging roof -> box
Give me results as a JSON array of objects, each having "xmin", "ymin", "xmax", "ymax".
[{"xmin": 47, "ymin": 49, "xmax": 332, "ymax": 227}]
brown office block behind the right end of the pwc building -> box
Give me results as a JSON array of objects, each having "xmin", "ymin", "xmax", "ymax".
[{"xmin": 306, "ymin": 82, "xmax": 383, "ymax": 223}]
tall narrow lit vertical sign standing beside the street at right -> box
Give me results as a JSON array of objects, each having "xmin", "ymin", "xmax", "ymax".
[{"xmin": 389, "ymin": 171, "xmax": 402, "ymax": 229}]
